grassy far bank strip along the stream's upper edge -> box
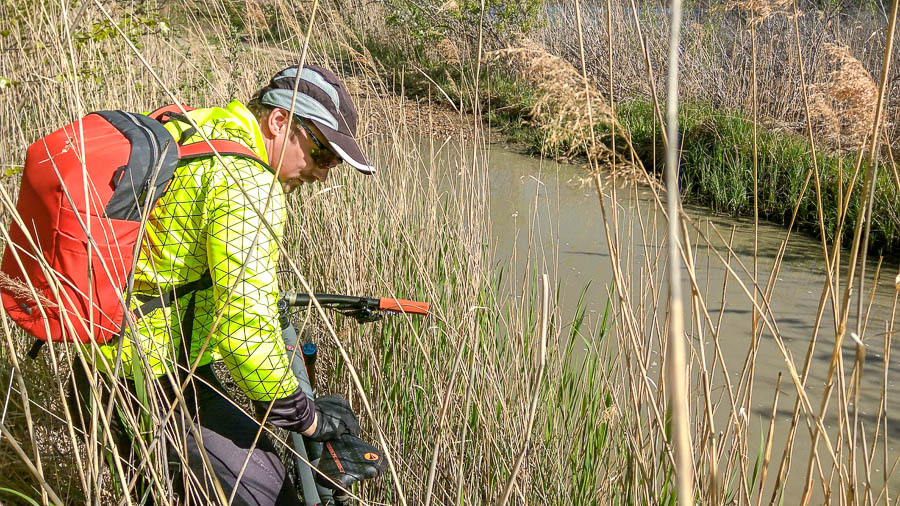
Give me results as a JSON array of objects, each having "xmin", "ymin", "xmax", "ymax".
[{"xmin": 368, "ymin": 38, "xmax": 900, "ymax": 255}]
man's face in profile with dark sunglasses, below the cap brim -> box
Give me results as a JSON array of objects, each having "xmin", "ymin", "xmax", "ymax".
[{"xmin": 267, "ymin": 109, "xmax": 337, "ymax": 193}]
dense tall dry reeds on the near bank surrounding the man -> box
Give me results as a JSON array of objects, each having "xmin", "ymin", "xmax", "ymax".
[{"xmin": 0, "ymin": 2, "xmax": 613, "ymax": 504}]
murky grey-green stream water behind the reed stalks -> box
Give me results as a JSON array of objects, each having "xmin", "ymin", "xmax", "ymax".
[{"xmin": 428, "ymin": 140, "xmax": 900, "ymax": 504}]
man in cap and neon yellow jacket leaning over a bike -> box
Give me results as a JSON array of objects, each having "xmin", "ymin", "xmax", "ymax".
[{"xmin": 69, "ymin": 65, "xmax": 375, "ymax": 505}]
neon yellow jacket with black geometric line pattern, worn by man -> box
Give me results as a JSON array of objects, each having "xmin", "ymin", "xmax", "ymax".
[{"xmin": 98, "ymin": 101, "xmax": 305, "ymax": 406}]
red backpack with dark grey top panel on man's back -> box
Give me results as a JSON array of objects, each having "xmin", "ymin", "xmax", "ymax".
[{"xmin": 0, "ymin": 105, "xmax": 265, "ymax": 354}]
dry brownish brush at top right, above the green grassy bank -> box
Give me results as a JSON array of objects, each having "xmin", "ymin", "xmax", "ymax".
[{"xmin": 542, "ymin": 0, "xmax": 900, "ymax": 150}]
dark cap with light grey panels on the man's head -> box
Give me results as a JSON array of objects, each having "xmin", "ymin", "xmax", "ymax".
[{"xmin": 256, "ymin": 65, "xmax": 375, "ymax": 174}]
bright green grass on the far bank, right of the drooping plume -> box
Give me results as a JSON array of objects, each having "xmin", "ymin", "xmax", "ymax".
[{"xmin": 619, "ymin": 101, "xmax": 900, "ymax": 253}]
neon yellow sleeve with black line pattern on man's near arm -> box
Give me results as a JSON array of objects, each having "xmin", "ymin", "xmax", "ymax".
[{"xmin": 206, "ymin": 157, "xmax": 315, "ymax": 430}]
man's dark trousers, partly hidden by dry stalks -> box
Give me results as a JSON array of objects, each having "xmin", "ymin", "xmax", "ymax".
[{"xmin": 69, "ymin": 365, "xmax": 300, "ymax": 506}]
